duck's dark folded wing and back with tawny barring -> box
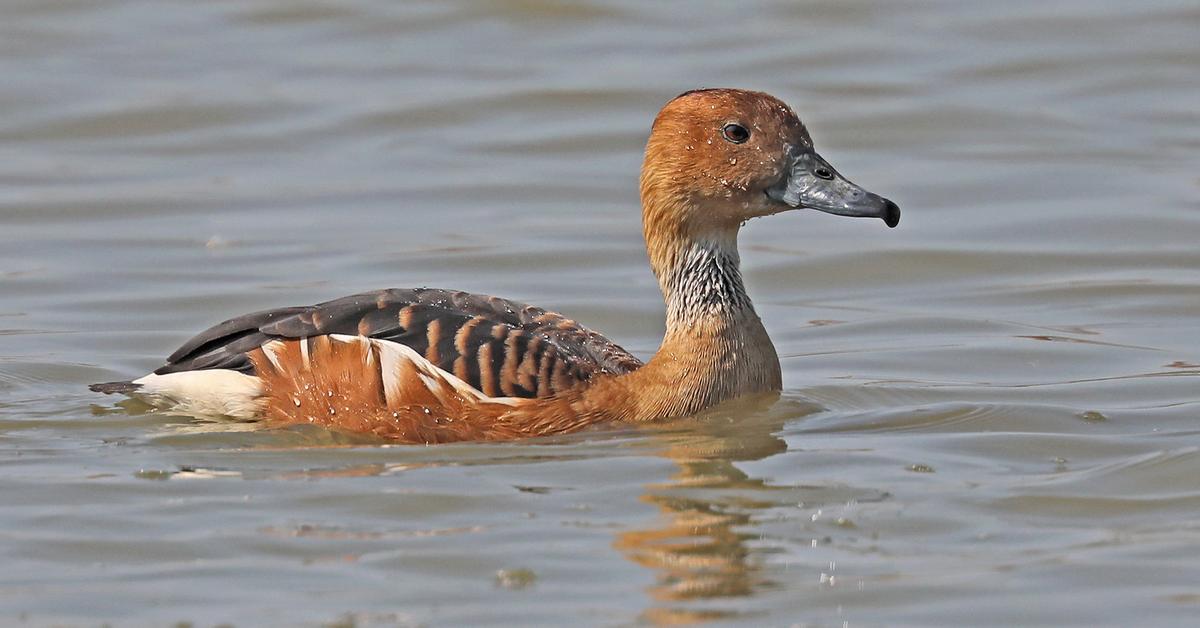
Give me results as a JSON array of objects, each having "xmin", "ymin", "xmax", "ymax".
[{"xmin": 155, "ymin": 288, "xmax": 642, "ymax": 397}]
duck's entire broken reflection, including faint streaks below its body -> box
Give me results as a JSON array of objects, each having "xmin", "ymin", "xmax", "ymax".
[{"xmin": 136, "ymin": 394, "xmax": 829, "ymax": 626}]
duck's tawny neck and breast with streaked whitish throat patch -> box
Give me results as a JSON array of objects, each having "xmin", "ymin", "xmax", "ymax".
[{"xmin": 592, "ymin": 216, "xmax": 781, "ymax": 421}]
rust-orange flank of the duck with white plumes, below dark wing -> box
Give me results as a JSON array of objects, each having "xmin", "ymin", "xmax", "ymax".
[{"xmin": 250, "ymin": 335, "xmax": 608, "ymax": 444}]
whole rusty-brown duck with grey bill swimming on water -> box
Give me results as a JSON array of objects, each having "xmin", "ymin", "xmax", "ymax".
[{"xmin": 90, "ymin": 89, "xmax": 900, "ymax": 444}]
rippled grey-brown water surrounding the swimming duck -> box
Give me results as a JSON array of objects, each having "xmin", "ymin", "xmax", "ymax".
[{"xmin": 0, "ymin": 0, "xmax": 1200, "ymax": 626}]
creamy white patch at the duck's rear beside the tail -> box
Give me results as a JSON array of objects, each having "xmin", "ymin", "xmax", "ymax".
[{"xmin": 131, "ymin": 369, "xmax": 263, "ymax": 420}]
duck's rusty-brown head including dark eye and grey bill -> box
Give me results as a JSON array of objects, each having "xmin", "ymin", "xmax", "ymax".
[{"xmin": 641, "ymin": 89, "xmax": 900, "ymax": 239}]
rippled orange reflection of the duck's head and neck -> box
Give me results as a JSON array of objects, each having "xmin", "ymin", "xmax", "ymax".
[{"xmin": 613, "ymin": 395, "xmax": 820, "ymax": 624}]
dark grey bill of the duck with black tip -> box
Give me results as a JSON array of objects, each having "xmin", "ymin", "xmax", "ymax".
[{"xmin": 767, "ymin": 150, "xmax": 900, "ymax": 227}]
